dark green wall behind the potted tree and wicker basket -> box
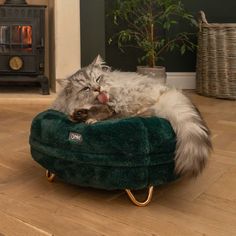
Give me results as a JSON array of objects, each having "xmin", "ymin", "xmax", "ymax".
[{"xmin": 81, "ymin": 0, "xmax": 236, "ymax": 72}]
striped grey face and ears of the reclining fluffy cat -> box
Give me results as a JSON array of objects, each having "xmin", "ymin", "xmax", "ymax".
[{"xmin": 60, "ymin": 54, "xmax": 108, "ymax": 109}]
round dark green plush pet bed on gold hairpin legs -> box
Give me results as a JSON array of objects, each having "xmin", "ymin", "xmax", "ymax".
[{"xmin": 30, "ymin": 110, "xmax": 177, "ymax": 205}]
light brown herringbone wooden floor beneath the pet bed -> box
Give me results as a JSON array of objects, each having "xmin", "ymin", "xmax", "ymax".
[{"xmin": 0, "ymin": 94, "xmax": 236, "ymax": 236}]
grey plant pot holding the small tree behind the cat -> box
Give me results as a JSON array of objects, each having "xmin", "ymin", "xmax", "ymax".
[{"xmin": 137, "ymin": 66, "xmax": 166, "ymax": 84}]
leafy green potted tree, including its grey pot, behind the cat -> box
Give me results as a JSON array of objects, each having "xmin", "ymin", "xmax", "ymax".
[{"xmin": 109, "ymin": 0, "xmax": 197, "ymax": 82}]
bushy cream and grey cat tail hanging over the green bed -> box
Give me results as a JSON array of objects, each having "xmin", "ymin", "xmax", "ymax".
[{"xmin": 157, "ymin": 90, "xmax": 212, "ymax": 176}]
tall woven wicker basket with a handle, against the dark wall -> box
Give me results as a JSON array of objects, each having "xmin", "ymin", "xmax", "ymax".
[{"xmin": 197, "ymin": 11, "xmax": 236, "ymax": 99}]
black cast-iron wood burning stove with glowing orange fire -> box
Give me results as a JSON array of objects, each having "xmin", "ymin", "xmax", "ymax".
[{"xmin": 0, "ymin": 0, "xmax": 49, "ymax": 94}]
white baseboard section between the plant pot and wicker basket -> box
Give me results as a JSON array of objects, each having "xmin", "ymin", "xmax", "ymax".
[{"xmin": 167, "ymin": 72, "xmax": 196, "ymax": 89}]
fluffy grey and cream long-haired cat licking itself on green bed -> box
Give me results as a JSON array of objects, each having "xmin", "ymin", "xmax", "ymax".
[{"xmin": 52, "ymin": 56, "xmax": 212, "ymax": 176}]
